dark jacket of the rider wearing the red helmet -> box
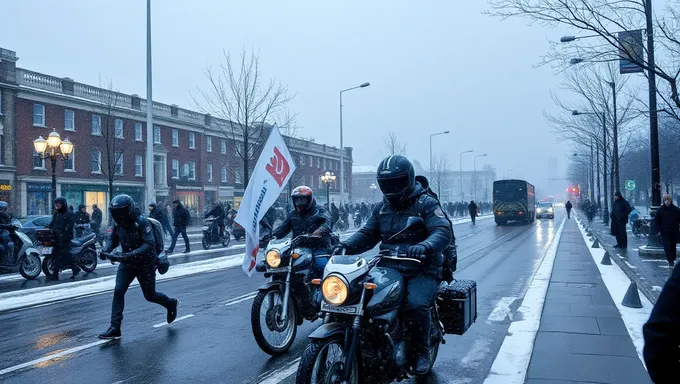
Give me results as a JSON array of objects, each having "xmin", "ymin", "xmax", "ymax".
[{"xmin": 272, "ymin": 201, "xmax": 333, "ymax": 251}]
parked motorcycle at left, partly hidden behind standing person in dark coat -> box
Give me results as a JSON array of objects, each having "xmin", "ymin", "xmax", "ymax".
[{"xmin": 35, "ymin": 229, "xmax": 97, "ymax": 277}]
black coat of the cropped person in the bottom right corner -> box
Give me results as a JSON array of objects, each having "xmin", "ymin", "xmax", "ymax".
[{"xmin": 642, "ymin": 267, "xmax": 680, "ymax": 384}]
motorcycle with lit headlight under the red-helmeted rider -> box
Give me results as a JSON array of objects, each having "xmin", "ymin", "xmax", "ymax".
[{"xmin": 250, "ymin": 235, "xmax": 330, "ymax": 355}]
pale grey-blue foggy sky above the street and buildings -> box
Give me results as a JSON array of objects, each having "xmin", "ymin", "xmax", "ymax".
[{"xmin": 0, "ymin": 0, "xmax": 573, "ymax": 191}]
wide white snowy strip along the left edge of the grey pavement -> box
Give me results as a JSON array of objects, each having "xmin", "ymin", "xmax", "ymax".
[{"xmin": 484, "ymin": 219, "xmax": 566, "ymax": 384}]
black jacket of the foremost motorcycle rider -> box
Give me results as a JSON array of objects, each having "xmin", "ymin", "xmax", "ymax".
[{"xmin": 343, "ymin": 182, "xmax": 453, "ymax": 278}]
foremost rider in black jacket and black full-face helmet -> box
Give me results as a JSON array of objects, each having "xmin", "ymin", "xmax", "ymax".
[{"xmin": 334, "ymin": 155, "xmax": 453, "ymax": 374}]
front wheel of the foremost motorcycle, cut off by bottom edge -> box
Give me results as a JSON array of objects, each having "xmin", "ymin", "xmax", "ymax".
[{"xmin": 295, "ymin": 336, "xmax": 360, "ymax": 384}]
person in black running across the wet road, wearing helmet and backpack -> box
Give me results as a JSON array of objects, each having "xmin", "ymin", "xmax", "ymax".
[{"xmin": 99, "ymin": 195, "xmax": 179, "ymax": 339}]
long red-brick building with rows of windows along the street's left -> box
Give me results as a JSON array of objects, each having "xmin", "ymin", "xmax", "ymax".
[{"xmin": 0, "ymin": 48, "xmax": 352, "ymax": 222}]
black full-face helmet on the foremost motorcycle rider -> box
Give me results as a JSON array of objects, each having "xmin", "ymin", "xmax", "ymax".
[{"xmin": 376, "ymin": 155, "xmax": 416, "ymax": 207}]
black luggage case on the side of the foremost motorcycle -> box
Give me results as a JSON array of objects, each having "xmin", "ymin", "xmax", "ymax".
[{"xmin": 437, "ymin": 280, "xmax": 477, "ymax": 335}]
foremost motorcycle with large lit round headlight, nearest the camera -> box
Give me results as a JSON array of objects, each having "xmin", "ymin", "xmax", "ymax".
[{"xmin": 295, "ymin": 217, "xmax": 445, "ymax": 384}]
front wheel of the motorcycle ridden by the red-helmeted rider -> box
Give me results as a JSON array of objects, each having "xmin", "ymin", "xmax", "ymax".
[{"xmin": 250, "ymin": 288, "xmax": 297, "ymax": 356}]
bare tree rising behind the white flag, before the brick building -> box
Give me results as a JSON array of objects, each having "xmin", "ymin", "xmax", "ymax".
[{"xmin": 196, "ymin": 50, "xmax": 292, "ymax": 185}]
